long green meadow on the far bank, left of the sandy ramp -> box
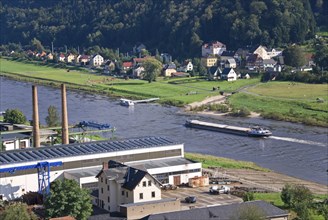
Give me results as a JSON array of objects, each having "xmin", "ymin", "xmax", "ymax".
[{"xmin": 0, "ymin": 59, "xmax": 259, "ymax": 106}]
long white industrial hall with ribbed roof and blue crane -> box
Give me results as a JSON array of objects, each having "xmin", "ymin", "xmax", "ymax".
[{"xmin": 0, "ymin": 137, "xmax": 201, "ymax": 200}]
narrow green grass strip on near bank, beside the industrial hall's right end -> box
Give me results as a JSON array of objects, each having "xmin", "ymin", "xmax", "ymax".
[{"xmin": 185, "ymin": 153, "xmax": 270, "ymax": 172}]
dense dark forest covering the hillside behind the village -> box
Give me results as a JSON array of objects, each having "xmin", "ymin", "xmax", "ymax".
[{"xmin": 0, "ymin": 0, "xmax": 328, "ymax": 58}]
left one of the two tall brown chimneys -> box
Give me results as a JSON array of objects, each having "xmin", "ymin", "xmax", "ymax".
[{"xmin": 32, "ymin": 85, "xmax": 40, "ymax": 147}]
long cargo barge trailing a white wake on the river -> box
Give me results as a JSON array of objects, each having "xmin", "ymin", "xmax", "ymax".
[{"xmin": 186, "ymin": 120, "xmax": 272, "ymax": 137}]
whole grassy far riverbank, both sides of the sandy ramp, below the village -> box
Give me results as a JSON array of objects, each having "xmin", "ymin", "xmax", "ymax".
[{"xmin": 0, "ymin": 58, "xmax": 328, "ymax": 127}]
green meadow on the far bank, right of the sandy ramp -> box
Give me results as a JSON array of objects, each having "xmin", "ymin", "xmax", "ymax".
[{"xmin": 229, "ymin": 82, "xmax": 328, "ymax": 126}]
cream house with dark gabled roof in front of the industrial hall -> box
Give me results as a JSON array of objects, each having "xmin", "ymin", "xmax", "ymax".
[{"xmin": 96, "ymin": 160, "xmax": 162, "ymax": 212}]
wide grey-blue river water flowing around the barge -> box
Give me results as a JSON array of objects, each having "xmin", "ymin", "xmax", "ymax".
[{"xmin": 0, "ymin": 77, "xmax": 328, "ymax": 185}]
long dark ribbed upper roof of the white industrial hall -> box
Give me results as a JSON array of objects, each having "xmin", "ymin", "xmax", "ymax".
[{"xmin": 0, "ymin": 137, "xmax": 180, "ymax": 165}]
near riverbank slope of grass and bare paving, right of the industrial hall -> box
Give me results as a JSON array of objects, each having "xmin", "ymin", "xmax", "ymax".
[{"xmin": 185, "ymin": 153, "xmax": 328, "ymax": 194}]
